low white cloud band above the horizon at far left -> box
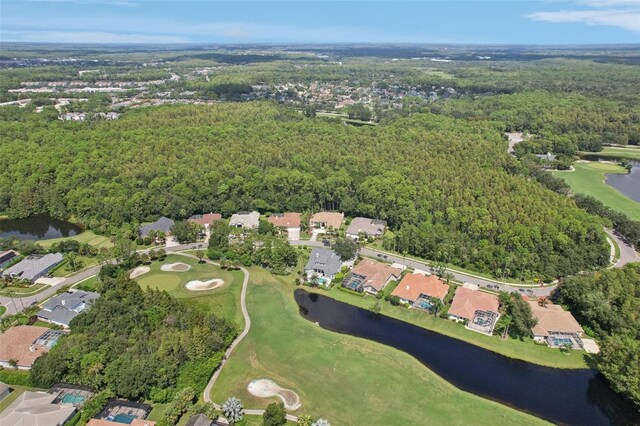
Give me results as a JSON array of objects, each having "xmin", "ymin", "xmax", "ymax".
[{"xmin": 2, "ymin": 31, "xmax": 192, "ymax": 44}]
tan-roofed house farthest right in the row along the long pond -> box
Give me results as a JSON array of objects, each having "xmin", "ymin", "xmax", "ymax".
[{"xmin": 529, "ymin": 301, "xmax": 584, "ymax": 349}]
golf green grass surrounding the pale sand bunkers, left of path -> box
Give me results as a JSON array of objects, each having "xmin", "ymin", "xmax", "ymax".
[{"xmin": 136, "ymin": 254, "xmax": 244, "ymax": 330}]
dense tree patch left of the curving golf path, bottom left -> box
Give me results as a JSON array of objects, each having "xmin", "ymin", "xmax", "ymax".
[{"xmin": 31, "ymin": 265, "xmax": 236, "ymax": 402}]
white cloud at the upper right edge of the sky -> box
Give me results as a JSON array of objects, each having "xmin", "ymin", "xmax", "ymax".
[{"xmin": 528, "ymin": 9, "xmax": 640, "ymax": 32}]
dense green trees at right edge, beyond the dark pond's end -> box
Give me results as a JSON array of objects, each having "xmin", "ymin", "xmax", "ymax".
[{"xmin": 556, "ymin": 263, "xmax": 640, "ymax": 407}]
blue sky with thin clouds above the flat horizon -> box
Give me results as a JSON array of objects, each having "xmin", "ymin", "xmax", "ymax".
[{"xmin": 0, "ymin": 0, "xmax": 640, "ymax": 44}]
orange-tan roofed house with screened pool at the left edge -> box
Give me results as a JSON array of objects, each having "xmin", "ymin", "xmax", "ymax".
[{"xmin": 0, "ymin": 325, "xmax": 64, "ymax": 370}]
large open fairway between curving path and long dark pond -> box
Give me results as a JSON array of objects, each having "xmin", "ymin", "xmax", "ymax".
[{"xmin": 212, "ymin": 268, "xmax": 544, "ymax": 425}]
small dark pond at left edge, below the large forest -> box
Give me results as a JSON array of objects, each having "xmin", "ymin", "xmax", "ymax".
[{"xmin": 0, "ymin": 215, "xmax": 82, "ymax": 240}]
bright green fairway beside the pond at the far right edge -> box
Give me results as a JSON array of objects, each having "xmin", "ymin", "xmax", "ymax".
[{"xmin": 553, "ymin": 161, "xmax": 640, "ymax": 220}]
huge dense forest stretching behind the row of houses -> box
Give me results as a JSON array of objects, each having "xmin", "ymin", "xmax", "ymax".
[{"xmin": 0, "ymin": 102, "xmax": 609, "ymax": 280}]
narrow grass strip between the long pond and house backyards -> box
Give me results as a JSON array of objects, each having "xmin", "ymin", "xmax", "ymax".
[{"xmin": 312, "ymin": 287, "xmax": 588, "ymax": 368}]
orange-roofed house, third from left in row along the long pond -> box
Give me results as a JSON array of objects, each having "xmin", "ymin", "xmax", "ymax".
[{"xmin": 391, "ymin": 273, "xmax": 449, "ymax": 310}]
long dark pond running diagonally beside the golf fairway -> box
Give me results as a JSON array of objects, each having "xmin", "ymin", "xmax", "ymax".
[{"xmin": 295, "ymin": 289, "xmax": 640, "ymax": 425}]
